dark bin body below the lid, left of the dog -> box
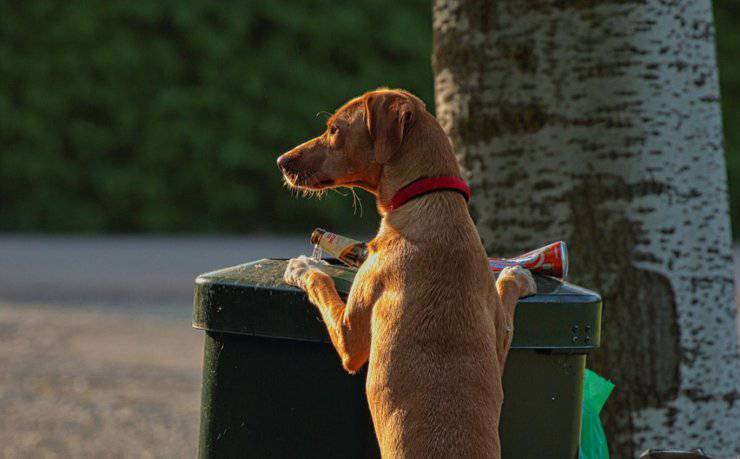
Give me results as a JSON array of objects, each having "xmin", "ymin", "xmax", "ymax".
[{"xmin": 200, "ymin": 332, "xmax": 379, "ymax": 458}]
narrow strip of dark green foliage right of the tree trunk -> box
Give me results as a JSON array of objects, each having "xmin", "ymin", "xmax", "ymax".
[{"xmin": 714, "ymin": 0, "xmax": 740, "ymax": 240}]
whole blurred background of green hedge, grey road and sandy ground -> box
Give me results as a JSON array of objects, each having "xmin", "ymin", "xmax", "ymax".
[{"xmin": 0, "ymin": 0, "xmax": 740, "ymax": 457}]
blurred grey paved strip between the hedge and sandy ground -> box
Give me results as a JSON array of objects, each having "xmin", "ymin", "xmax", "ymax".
[{"xmin": 0, "ymin": 236, "xmax": 311, "ymax": 305}]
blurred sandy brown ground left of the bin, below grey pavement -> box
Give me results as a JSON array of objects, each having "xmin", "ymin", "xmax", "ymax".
[{"xmin": 0, "ymin": 303, "xmax": 202, "ymax": 458}]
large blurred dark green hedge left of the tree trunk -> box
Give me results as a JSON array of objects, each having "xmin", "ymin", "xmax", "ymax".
[{"xmin": 0, "ymin": 0, "xmax": 433, "ymax": 233}]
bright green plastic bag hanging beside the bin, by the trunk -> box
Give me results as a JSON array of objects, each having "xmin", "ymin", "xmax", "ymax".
[{"xmin": 579, "ymin": 370, "xmax": 614, "ymax": 459}]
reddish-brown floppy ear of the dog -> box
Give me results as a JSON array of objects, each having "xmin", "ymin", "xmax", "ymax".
[{"xmin": 365, "ymin": 94, "xmax": 416, "ymax": 164}]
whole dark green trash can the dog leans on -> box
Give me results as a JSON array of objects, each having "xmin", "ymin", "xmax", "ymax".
[{"xmin": 193, "ymin": 259, "xmax": 601, "ymax": 459}]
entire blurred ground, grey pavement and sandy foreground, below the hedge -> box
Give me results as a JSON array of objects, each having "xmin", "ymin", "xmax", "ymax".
[{"xmin": 0, "ymin": 236, "xmax": 740, "ymax": 458}]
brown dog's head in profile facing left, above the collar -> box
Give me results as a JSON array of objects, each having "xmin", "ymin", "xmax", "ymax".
[{"xmin": 277, "ymin": 89, "xmax": 425, "ymax": 192}]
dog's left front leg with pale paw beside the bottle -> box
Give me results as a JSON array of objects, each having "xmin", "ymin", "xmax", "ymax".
[{"xmin": 285, "ymin": 257, "xmax": 375, "ymax": 373}]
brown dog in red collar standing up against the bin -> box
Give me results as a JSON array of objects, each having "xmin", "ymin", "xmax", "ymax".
[{"xmin": 278, "ymin": 89, "xmax": 535, "ymax": 458}]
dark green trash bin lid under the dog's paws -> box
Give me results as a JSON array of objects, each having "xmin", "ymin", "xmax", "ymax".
[{"xmin": 193, "ymin": 259, "xmax": 601, "ymax": 353}]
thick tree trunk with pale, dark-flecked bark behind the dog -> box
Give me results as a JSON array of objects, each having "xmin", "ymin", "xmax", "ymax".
[{"xmin": 433, "ymin": 0, "xmax": 740, "ymax": 458}]
